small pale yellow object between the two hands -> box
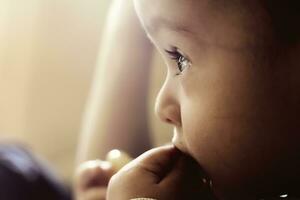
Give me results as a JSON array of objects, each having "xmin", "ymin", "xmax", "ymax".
[{"xmin": 106, "ymin": 149, "xmax": 132, "ymax": 172}]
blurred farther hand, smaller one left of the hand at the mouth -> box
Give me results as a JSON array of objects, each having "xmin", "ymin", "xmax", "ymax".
[{"xmin": 74, "ymin": 160, "xmax": 114, "ymax": 200}]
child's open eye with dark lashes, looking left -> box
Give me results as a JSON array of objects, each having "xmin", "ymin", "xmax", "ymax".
[{"xmin": 165, "ymin": 47, "xmax": 191, "ymax": 75}]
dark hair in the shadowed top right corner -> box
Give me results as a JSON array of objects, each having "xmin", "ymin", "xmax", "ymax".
[{"xmin": 263, "ymin": 0, "xmax": 300, "ymax": 44}]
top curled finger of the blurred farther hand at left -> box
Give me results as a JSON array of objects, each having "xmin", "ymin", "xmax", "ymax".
[{"xmin": 75, "ymin": 160, "xmax": 113, "ymax": 191}]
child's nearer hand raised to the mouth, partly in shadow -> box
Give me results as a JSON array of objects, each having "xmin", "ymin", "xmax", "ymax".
[{"xmin": 107, "ymin": 146, "xmax": 213, "ymax": 200}]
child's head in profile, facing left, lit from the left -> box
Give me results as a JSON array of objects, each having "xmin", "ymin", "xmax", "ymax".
[{"xmin": 135, "ymin": 0, "xmax": 300, "ymax": 196}]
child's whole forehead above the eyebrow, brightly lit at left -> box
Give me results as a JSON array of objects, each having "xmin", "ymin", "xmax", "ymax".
[{"xmin": 135, "ymin": 0, "xmax": 265, "ymax": 49}]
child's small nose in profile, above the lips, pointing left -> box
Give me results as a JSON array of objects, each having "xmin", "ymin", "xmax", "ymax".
[{"xmin": 155, "ymin": 78, "xmax": 181, "ymax": 127}]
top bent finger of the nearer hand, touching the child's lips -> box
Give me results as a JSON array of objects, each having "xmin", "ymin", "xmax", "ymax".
[{"xmin": 122, "ymin": 145, "xmax": 181, "ymax": 183}]
